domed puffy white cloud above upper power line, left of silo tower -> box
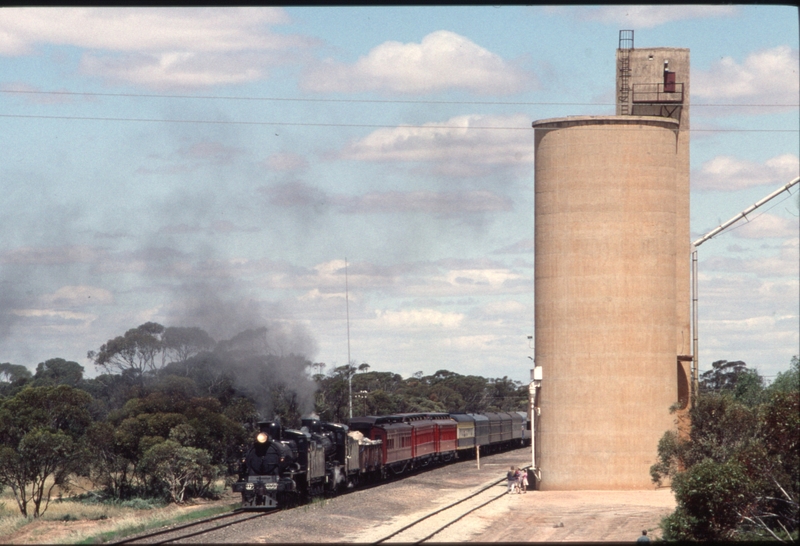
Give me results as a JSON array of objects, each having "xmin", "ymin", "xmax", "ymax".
[{"xmin": 301, "ymin": 30, "xmax": 532, "ymax": 95}]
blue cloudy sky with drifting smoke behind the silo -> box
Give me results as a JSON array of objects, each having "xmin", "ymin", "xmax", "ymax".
[{"xmin": 0, "ymin": 5, "xmax": 800, "ymax": 382}]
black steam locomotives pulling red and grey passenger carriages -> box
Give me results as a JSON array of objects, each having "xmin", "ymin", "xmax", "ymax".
[{"xmin": 233, "ymin": 412, "xmax": 530, "ymax": 510}]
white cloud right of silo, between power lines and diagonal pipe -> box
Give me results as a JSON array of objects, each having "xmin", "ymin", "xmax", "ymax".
[{"xmin": 692, "ymin": 154, "xmax": 800, "ymax": 191}]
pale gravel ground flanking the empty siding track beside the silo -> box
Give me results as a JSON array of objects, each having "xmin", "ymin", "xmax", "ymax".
[{"xmin": 181, "ymin": 448, "xmax": 675, "ymax": 543}]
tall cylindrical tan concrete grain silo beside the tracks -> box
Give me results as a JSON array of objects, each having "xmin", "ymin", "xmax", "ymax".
[{"xmin": 533, "ymin": 31, "xmax": 691, "ymax": 490}]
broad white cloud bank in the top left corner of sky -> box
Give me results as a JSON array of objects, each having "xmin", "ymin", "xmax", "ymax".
[{"xmin": 0, "ymin": 8, "xmax": 305, "ymax": 89}]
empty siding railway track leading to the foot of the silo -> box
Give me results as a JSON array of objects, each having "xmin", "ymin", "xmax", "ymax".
[{"xmin": 372, "ymin": 466, "xmax": 529, "ymax": 544}]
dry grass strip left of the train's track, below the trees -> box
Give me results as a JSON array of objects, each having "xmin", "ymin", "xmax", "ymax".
[{"xmin": 0, "ymin": 474, "xmax": 234, "ymax": 544}]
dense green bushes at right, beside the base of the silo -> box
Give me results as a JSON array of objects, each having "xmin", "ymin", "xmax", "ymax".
[{"xmin": 650, "ymin": 359, "xmax": 800, "ymax": 540}]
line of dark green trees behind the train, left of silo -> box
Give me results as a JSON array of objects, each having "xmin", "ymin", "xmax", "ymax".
[{"xmin": 0, "ymin": 322, "xmax": 527, "ymax": 517}]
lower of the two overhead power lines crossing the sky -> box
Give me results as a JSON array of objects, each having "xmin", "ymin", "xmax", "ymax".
[{"xmin": 0, "ymin": 114, "xmax": 800, "ymax": 133}]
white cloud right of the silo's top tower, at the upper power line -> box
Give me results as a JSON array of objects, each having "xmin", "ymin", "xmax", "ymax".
[{"xmin": 692, "ymin": 46, "xmax": 800, "ymax": 106}]
